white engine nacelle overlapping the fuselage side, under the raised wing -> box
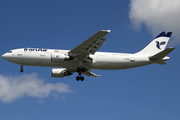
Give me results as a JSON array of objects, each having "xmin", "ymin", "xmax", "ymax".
[{"xmin": 51, "ymin": 53, "xmax": 70, "ymax": 62}]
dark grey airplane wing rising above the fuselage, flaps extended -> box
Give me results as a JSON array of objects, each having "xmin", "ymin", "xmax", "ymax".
[{"xmin": 69, "ymin": 30, "xmax": 110, "ymax": 57}]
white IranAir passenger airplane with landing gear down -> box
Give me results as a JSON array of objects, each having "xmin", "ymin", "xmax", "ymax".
[{"xmin": 2, "ymin": 30, "xmax": 175, "ymax": 81}]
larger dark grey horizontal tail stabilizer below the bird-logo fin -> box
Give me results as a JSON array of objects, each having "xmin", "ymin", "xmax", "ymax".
[{"xmin": 149, "ymin": 48, "xmax": 175, "ymax": 61}]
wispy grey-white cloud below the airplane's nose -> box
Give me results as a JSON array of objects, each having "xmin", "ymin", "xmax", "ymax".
[{"xmin": 0, "ymin": 73, "xmax": 72, "ymax": 102}]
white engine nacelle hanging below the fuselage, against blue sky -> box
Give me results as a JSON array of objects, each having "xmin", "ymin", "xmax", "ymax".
[{"xmin": 51, "ymin": 68, "xmax": 72, "ymax": 77}]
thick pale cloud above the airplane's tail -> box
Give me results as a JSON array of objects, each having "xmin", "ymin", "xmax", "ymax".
[{"xmin": 129, "ymin": 0, "xmax": 180, "ymax": 44}]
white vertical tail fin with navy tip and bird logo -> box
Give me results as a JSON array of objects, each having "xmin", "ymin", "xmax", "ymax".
[{"xmin": 136, "ymin": 32, "xmax": 172, "ymax": 54}]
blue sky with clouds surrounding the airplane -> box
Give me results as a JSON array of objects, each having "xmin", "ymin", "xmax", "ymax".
[{"xmin": 0, "ymin": 0, "xmax": 180, "ymax": 120}]
